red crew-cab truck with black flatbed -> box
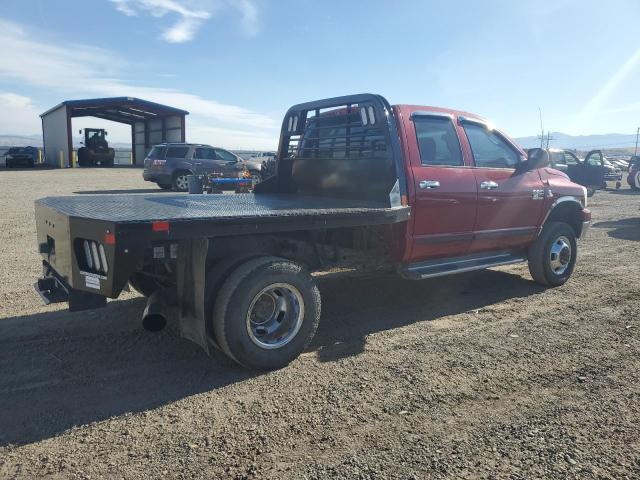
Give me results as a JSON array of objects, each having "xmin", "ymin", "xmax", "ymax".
[{"xmin": 36, "ymin": 94, "xmax": 591, "ymax": 369}]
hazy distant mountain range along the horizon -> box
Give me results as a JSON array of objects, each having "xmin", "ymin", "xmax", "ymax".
[{"xmin": 0, "ymin": 132, "xmax": 636, "ymax": 150}]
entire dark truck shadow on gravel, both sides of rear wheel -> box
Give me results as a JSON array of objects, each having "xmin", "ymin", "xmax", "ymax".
[{"xmin": 0, "ymin": 271, "xmax": 543, "ymax": 446}]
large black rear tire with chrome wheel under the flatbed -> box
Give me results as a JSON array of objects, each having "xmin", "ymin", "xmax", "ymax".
[{"xmin": 213, "ymin": 257, "xmax": 320, "ymax": 370}]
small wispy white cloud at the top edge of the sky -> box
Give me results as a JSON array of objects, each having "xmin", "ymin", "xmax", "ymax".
[{"xmin": 111, "ymin": 0, "xmax": 259, "ymax": 43}]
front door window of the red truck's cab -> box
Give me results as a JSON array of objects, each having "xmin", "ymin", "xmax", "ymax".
[{"xmin": 464, "ymin": 123, "xmax": 520, "ymax": 168}]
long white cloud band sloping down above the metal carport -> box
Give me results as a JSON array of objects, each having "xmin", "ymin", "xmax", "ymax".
[{"xmin": 0, "ymin": 19, "xmax": 279, "ymax": 148}]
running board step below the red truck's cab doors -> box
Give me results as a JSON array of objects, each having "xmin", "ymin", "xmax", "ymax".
[{"xmin": 401, "ymin": 251, "xmax": 527, "ymax": 280}]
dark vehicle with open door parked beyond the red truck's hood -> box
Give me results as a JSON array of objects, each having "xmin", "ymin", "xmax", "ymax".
[{"xmin": 549, "ymin": 148, "xmax": 622, "ymax": 196}]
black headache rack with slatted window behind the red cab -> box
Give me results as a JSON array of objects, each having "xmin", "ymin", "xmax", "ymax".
[{"xmin": 256, "ymin": 94, "xmax": 406, "ymax": 206}]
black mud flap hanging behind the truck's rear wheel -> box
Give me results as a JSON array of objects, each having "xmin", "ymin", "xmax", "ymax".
[{"xmin": 177, "ymin": 238, "xmax": 209, "ymax": 353}]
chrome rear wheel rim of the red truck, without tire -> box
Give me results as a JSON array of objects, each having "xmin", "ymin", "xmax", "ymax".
[{"xmin": 247, "ymin": 283, "xmax": 304, "ymax": 349}]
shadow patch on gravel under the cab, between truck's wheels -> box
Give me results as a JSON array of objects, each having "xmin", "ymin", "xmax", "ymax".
[{"xmin": 311, "ymin": 270, "xmax": 544, "ymax": 362}]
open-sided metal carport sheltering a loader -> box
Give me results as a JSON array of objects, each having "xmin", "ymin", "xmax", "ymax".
[{"xmin": 40, "ymin": 97, "xmax": 189, "ymax": 167}]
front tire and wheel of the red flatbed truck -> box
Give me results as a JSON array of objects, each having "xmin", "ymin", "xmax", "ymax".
[{"xmin": 528, "ymin": 222, "xmax": 578, "ymax": 287}]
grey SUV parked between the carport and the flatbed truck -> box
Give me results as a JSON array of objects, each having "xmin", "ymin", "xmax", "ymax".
[{"xmin": 142, "ymin": 143, "xmax": 245, "ymax": 192}]
